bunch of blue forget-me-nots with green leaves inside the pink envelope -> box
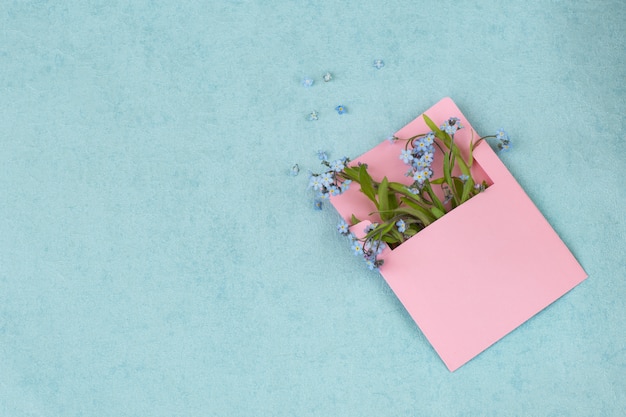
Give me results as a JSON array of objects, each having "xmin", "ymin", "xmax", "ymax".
[{"xmin": 309, "ymin": 114, "xmax": 511, "ymax": 269}]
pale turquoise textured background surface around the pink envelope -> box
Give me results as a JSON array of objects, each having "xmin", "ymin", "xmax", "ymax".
[{"xmin": 0, "ymin": 0, "xmax": 626, "ymax": 417}]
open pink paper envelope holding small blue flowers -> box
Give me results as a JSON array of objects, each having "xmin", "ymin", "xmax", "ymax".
[{"xmin": 331, "ymin": 98, "xmax": 587, "ymax": 371}]
